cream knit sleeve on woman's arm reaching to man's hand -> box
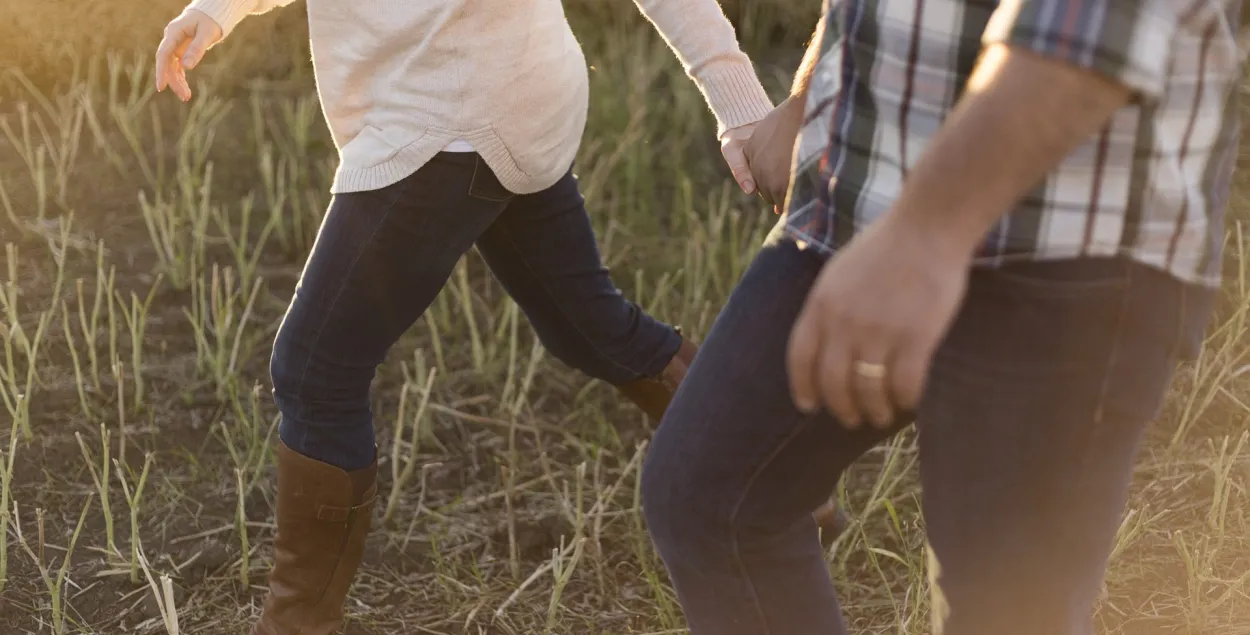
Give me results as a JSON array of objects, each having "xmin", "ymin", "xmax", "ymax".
[{"xmin": 634, "ymin": 0, "xmax": 773, "ymax": 135}]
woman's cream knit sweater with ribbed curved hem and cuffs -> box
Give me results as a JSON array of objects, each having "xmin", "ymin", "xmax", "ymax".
[{"xmin": 190, "ymin": 0, "xmax": 771, "ymax": 194}]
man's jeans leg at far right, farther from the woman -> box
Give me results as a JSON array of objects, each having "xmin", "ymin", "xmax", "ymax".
[{"xmin": 915, "ymin": 260, "xmax": 1211, "ymax": 635}]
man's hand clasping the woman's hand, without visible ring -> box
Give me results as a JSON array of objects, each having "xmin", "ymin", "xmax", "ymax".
[{"xmin": 745, "ymin": 96, "xmax": 804, "ymax": 211}]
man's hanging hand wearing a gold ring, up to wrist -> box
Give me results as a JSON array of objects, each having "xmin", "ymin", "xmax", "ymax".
[{"xmin": 788, "ymin": 213, "xmax": 971, "ymax": 428}]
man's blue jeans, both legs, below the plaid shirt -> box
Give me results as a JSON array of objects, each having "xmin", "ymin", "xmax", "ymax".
[{"xmin": 643, "ymin": 241, "xmax": 1213, "ymax": 635}]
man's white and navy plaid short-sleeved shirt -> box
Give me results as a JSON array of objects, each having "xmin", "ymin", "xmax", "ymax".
[{"xmin": 778, "ymin": 0, "xmax": 1243, "ymax": 285}]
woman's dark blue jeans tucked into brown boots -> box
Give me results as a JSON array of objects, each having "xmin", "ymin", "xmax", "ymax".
[{"xmin": 270, "ymin": 153, "xmax": 681, "ymax": 471}]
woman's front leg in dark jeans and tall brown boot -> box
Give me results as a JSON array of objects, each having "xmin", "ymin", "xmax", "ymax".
[{"xmin": 254, "ymin": 155, "xmax": 503, "ymax": 635}]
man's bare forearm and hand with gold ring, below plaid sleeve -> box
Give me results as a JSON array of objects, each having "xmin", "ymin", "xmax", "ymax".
[{"xmin": 785, "ymin": 44, "xmax": 1131, "ymax": 426}]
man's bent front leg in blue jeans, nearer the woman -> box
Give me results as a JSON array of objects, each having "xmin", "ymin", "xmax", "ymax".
[{"xmin": 643, "ymin": 241, "xmax": 899, "ymax": 635}]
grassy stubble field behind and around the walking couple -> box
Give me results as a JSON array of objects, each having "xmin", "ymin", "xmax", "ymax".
[{"xmin": 0, "ymin": 0, "xmax": 1250, "ymax": 635}]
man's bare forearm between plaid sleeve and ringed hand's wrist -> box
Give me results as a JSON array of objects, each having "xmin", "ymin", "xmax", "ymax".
[{"xmin": 895, "ymin": 45, "xmax": 1130, "ymax": 255}]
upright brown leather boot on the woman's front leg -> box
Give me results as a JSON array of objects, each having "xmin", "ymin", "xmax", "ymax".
[{"xmin": 253, "ymin": 443, "xmax": 378, "ymax": 635}]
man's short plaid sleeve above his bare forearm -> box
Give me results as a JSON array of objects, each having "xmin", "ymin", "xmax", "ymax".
[{"xmin": 983, "ymin": 0, "xmax": 1183, "ymax": 99}]
